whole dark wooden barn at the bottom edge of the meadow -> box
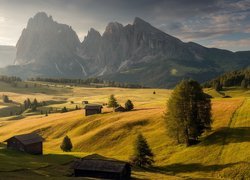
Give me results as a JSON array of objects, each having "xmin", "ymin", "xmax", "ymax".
[{"xmin": 73, "ymin": 156, "xmax": 131, "ymax": 180}]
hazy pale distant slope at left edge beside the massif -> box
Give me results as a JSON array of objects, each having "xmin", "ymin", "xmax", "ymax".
[{"xmin": 0, "ymin": 46, "xmax": 16, "ymax": 68}]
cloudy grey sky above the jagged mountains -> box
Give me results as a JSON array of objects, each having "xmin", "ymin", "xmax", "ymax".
[{"xmin": 0, "ymin": 0, "xmax": 250, "ymax": 51}]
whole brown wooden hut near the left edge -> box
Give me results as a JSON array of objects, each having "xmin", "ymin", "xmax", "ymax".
[{"xmin": 4, "ymin": 133, "xmax": 43, "ymax": 155}]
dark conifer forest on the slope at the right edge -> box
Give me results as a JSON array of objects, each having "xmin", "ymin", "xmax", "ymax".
[{"xmin": 203, "ymin": 68, "xmax": 250, "ymax": 90}]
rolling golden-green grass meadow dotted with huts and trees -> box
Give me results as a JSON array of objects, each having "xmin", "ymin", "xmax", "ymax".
[{"xmin": 0, "ymin": 83, "xmax": 250, "ymax": 179}]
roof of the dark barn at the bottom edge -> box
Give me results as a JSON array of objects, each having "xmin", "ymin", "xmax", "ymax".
[{"xmin": 73, "ymin": 155, "xmax": 128, "ymax": 173}]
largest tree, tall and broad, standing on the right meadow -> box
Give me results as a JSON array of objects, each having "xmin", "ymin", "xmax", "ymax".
[{"xmin": 164, "ymin": 80, "xmax": 212, "ymax": 146}]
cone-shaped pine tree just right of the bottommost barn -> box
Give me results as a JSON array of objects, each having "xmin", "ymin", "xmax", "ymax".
[{"xmin": 131, "ymin": 134, "xmax": 154, "ymax": 167}]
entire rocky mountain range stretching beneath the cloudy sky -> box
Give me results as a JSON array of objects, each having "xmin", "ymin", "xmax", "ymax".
[{"xmin": 0, "ymin": 12, "xmax": 250, "ymax": 87}]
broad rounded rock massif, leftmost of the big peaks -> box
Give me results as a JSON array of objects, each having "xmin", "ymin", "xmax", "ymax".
[{"xmin": 15, "ymin": 13, "xmax": 87, "ymax": 76}]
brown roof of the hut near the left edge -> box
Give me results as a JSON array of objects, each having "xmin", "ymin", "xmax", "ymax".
[{"xmin": 4, "ymin": 133, "xmax": 43, "ymax": 145}]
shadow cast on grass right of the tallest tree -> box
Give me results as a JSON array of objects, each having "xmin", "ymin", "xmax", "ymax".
[{"xmin": 200, "ymin": 127, "xmax": 250, "ymax": 146}]
